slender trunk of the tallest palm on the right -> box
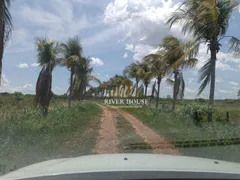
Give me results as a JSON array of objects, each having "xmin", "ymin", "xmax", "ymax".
[{"xmin": 208, "ymin": 43, "xmax": 217, "ymax": 122}]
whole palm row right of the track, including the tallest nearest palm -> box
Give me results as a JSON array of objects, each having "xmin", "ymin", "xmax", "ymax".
[{"xmin": 88, "ymin": 0, "xmax": 240, "ymax": 121}]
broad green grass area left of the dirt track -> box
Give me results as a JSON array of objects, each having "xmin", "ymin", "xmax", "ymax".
[{"xmin": 0, "ymin": 97, "xmax": 100, "ymax": 175}]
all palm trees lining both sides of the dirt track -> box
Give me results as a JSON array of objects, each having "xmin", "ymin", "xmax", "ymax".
[{"xmin": 0, "ymin": 0, "xmax": 240, "ymax": 121}]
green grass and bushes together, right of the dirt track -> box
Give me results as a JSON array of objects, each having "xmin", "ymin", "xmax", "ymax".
[{"xmin": 124, "ymin": 101, "xmax": 240, "ymax": 162}]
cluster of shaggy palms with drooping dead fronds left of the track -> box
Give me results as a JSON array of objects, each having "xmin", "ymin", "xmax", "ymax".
[{"xmin": 35, "ymin": 37, "xmax": 100, "ymax": 115}]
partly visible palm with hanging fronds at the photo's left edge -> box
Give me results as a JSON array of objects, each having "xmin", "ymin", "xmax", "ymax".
[{"xmin": 0, "ymin": 0, "xmax": 13, "ymax": 85}]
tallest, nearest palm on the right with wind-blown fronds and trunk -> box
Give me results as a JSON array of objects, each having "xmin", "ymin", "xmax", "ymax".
[{"xmin": 167, "ymin": 0, "xmax": 240, "ymax": 121}]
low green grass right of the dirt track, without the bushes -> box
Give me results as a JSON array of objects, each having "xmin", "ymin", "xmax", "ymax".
[{"xmin": 124, "ymin": 106, "xmax": 240, "ymax": 162}]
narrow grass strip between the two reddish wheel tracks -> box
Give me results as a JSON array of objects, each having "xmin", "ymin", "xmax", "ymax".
[{"xmin": 116, "ymin": 113, "xmax": 152, "ymax": 153}]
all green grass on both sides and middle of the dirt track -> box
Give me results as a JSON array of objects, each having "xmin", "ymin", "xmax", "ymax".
[{"xmin": 0, "ymin": 94, "xmax": 240, "ymax": 175}]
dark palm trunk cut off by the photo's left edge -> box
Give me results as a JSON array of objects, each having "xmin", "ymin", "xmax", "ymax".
[{"xmin": 0, "ymin": 0, "xmax": 5, "ymax": 85}]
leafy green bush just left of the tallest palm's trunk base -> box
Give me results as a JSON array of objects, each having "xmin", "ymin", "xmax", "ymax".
[{"xmin": 180, "ymin": 103, "xmax": 208, "ymax": 125}]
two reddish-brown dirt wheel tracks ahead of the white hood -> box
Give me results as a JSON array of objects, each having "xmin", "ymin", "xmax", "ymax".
[{"xmin": 95, "ymin": 106, "xmax": 180, "ymax": 155}]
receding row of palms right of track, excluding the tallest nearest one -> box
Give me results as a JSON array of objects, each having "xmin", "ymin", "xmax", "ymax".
[{"xmin": 90, "ymin": 36, "xmax": 198, "ymax": 111}]
